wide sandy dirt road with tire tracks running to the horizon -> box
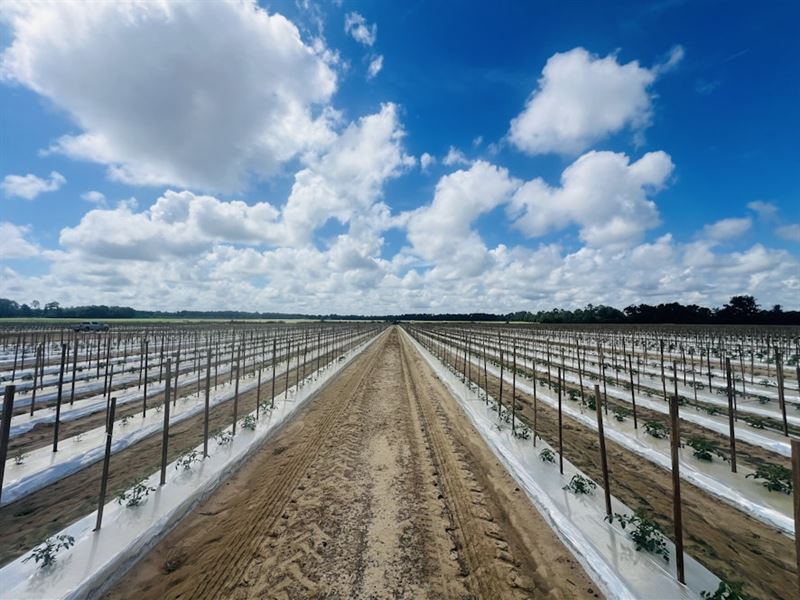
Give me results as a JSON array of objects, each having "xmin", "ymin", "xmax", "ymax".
[{"xmin": 108, "ymin": 328, "xmax": 598, "ymax": 600}]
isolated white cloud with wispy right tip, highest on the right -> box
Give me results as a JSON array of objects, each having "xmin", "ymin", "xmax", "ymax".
[{"xmin": 509, "ymin": 47, "xmax": 683, "ymax": 154}]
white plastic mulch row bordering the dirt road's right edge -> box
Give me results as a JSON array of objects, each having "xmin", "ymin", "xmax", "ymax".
[{"xmin": 409, "ymin": 336, "xmax": 719, "ymax": 600}]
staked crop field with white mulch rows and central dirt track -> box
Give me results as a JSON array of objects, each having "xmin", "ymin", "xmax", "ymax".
[{"xmin": 0, "ymin": 322, "xmax": 800, "ymax": 598}]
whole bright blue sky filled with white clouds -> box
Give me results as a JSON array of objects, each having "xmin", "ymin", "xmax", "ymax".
[{"xmin": 0, "ymin": 0, "xmax": 800, "ymax": 314}]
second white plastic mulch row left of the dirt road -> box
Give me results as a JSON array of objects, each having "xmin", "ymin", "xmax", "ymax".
[{"xmin": 0, "ymin": 338, "xmax": 350, "ymax": 506}]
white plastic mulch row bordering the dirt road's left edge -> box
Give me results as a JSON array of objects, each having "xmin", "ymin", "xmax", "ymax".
[{"xmin": 0, "ymin": 328, "xmax": 378, "ymax": 599}]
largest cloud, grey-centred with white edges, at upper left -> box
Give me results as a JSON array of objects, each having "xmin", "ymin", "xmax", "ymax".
[{"xmin": 0, "ymin": 0, "xmax": 336, "ymax": 190}]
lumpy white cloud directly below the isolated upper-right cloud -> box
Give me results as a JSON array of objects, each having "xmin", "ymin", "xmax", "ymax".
[{"xmin": 509, "ymin": 151, "xmax": 674, "ymax": 247}]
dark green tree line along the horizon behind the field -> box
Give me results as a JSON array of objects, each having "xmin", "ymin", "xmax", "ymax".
[{"xmin": 0, "ymin": 296, "xmax": 800, "ymax": 325}]
